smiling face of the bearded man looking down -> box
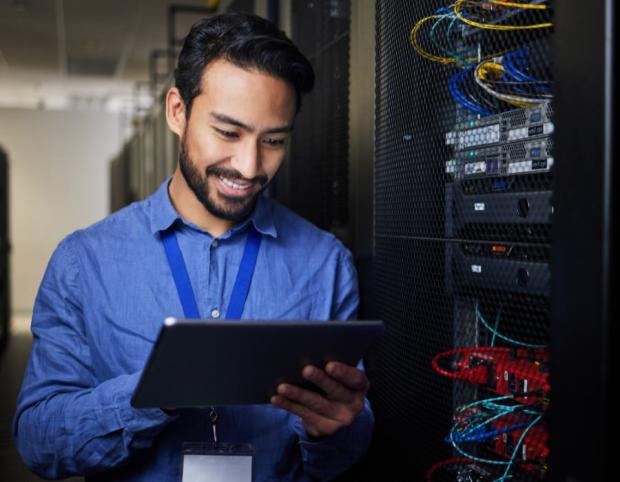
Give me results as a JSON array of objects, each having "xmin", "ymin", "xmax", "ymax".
[{"xmin": 179, "ymin": 59, "xmax": 296, "ymax": 222}]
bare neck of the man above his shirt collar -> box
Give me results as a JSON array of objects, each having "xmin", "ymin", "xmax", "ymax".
[{"xmin": 168, "ymin": 165, "xmax": 234, "ymax": 238}]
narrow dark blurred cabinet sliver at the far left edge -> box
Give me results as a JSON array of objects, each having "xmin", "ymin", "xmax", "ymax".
[{"xmin": 0, "ymin": 148, "xmax": 11, "ymax": 349}]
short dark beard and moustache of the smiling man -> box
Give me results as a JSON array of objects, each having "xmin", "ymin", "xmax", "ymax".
[{"xmin": 179, "ymin": 136, "xmax": 268, "ymax": 223}]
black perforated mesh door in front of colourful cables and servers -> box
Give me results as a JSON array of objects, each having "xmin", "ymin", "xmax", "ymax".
[{"xmin": 372, "ymin": 0, "xmax": 554, "ymax": 481}]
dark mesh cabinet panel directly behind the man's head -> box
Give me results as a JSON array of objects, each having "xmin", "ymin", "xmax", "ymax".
[{"xmin": 287, "ymin": 0, "xmax": 350, "ymax": 230}]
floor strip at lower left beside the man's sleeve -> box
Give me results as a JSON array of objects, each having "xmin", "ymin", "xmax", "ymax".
[{"xmin": 0, "ymin": 313, "xmax": 83, "ymax": 482}]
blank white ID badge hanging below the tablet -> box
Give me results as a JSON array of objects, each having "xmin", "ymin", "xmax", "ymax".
[{"xmin": 181, "ymin": 443, "xmax": 254, "ymax": 482}]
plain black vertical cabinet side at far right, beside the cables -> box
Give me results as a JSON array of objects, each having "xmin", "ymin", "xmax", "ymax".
[{"xmin": 550, "ymin": 0, "xmax": 620, "ymax": 482}]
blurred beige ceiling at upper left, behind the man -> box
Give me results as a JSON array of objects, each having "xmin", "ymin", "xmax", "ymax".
[{"xmin": 0, "ymin": 0, "xmax": 230, "ymax": 110}]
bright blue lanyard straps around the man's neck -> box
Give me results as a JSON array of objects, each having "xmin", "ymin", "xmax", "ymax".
[{"xmin": 162, "ymin": 226, "xmax": 261, "ymax": 320}]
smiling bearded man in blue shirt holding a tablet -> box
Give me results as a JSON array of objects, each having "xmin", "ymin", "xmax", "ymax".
[{"xmin": 14, "ymin": 11, "xmax": 373, "ymax": 482}]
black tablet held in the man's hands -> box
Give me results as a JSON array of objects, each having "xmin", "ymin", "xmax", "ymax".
[{"xmin": 131, "ymin": 318, "xmax": 384, "ymax": 408}]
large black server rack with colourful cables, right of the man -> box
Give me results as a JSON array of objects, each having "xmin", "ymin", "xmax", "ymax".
[{"xmin": 358, "ymin": 0, "xmax": 617, "ymax": 481}]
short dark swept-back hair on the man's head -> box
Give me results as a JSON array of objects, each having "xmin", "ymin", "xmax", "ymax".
[{"xmin": 174, "ymin": 13, "xmax": 314, "ymax": 118}]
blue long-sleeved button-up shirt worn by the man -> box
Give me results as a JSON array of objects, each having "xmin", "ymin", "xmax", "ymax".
[{"xmin": 13, "ymin": 180, "xmax": 373, "ymax": 482}]
